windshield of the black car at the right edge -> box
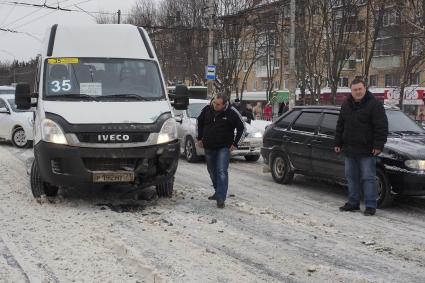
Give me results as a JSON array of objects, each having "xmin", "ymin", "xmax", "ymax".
[{"xmin": 386, "ymin": 110, "xmax": 425, "ymax": 134}]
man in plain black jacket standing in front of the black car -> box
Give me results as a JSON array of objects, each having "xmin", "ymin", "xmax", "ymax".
[{"xmin": 335, "ymin": 78, "xmax": 388, "ymax": 215}]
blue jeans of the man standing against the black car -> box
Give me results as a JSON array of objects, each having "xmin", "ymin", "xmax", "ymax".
[{"xmin": 345, "ymin": 157, "xmax": 378, "ymax": 208}]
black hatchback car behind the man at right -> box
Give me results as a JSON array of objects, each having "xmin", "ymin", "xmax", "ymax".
[{"xmin": 261, "ymin": 106, "xmax": 425, "ymax": 207}]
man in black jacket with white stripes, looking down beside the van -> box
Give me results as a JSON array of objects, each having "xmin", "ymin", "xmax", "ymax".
[{"xmin": 197, "ymin": 94, "xmax": 246, "ymax": 208}]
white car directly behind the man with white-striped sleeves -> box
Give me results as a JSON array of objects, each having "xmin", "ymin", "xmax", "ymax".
[{"xmin": 174, "ymin": 99, "xmax": 263, "ymax": 162}]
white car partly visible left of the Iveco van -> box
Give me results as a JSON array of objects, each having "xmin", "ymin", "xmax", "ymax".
[{"xmin": 0, "ymin": 94, "xmax": 34, "ymax": 148}]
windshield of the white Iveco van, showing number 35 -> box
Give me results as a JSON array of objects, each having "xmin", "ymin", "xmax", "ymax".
[{"xmin": 44, "ymin": 58, "xmax": 164, "ymax": 101}]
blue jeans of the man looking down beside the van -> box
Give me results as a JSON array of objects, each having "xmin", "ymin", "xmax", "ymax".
[{"xmin": 205, "ymin": 147, "xmax": 230, "ymax": 201}]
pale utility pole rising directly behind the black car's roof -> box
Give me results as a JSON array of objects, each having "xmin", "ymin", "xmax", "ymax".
[{"xmin": 288, "ymin": 0, "xmax": 297, "ymax": 109}]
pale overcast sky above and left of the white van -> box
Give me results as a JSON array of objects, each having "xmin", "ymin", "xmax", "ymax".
[{"xmin": 0, "ymin": 0, "xmax": 137, "ymax": 61}]
